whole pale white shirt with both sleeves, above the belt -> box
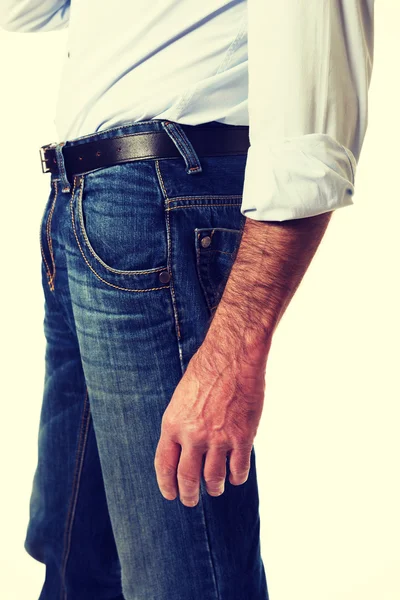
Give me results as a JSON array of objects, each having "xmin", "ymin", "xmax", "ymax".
[{"xmin": 0, "ymin": 0, "xmax": 374, "ymax": 221}]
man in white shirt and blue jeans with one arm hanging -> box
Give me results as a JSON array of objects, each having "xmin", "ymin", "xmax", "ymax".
[{"xmin": 1, "ymin": 0, "xmax": 374, "ymax": 600}]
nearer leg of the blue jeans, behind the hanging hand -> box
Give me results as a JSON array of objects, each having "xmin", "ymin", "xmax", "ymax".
[{"xmin": 68, "ymin": 156, "xmax": 267, "ymax": 600}]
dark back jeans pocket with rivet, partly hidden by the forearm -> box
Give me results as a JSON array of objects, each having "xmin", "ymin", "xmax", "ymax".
[{"xmin": 195, "ymin": 227, "xmax": 242, "ymax": 314}]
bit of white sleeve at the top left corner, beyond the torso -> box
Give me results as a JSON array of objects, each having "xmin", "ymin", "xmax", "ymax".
[{"xmin": 0, "ymin": 0, "xmax": 70, "ymax": 33}]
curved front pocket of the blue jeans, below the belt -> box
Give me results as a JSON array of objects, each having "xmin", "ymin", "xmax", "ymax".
[{"xmin": 71, "ymin": 161, "xmax": 169, "ymax": 291}]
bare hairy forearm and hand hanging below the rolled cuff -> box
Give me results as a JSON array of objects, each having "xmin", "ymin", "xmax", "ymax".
[{"xmin": 154, "ymin": 212, "xmax": 332, "ymax": 506}]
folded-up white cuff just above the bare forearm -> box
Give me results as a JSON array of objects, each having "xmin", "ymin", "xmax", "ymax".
[{"xmin": 240, "ymin": 133, "xmax": 357, "ymax": 221}]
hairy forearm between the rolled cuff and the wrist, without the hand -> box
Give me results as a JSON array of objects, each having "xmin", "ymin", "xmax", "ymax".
[{"xmin": 205, "ymin": 212, "xmax": 332, "ymax": 362}]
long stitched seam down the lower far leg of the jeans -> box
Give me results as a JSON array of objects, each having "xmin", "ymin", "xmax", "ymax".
[{"xmin": 60, "ymin": 389, "xmax": 90, "ymax": 600}]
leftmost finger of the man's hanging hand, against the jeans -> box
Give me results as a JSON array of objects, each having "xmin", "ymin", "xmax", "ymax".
[{"xmin": 154, "ymin": 435, "xmax": 181, "ymax": 500}]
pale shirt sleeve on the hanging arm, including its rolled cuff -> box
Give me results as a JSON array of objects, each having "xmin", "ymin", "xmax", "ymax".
[{"xmin": 241, "ymin": 0, "xmax": 374, "ymax": 221}]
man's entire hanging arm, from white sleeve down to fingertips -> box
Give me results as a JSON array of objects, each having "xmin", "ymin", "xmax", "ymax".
[{"xmin": 154, "ymin": 0, "xmax": 374, "ymax": 506}]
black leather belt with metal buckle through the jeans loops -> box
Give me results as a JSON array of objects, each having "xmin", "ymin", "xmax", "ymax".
[{"xmin": 40, "ymin": 125, "xmax": 250, "ymax": 183}]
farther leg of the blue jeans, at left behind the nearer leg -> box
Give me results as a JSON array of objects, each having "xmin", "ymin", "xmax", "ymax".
[{"xmin": 24, "ymin": 202, "xmax": 122, "ymax": 600}]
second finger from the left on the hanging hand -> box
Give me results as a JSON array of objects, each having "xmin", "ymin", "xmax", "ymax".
[{"xmin": 178, "ymin": 445, "xmax": 204, "ymax": 506}]
